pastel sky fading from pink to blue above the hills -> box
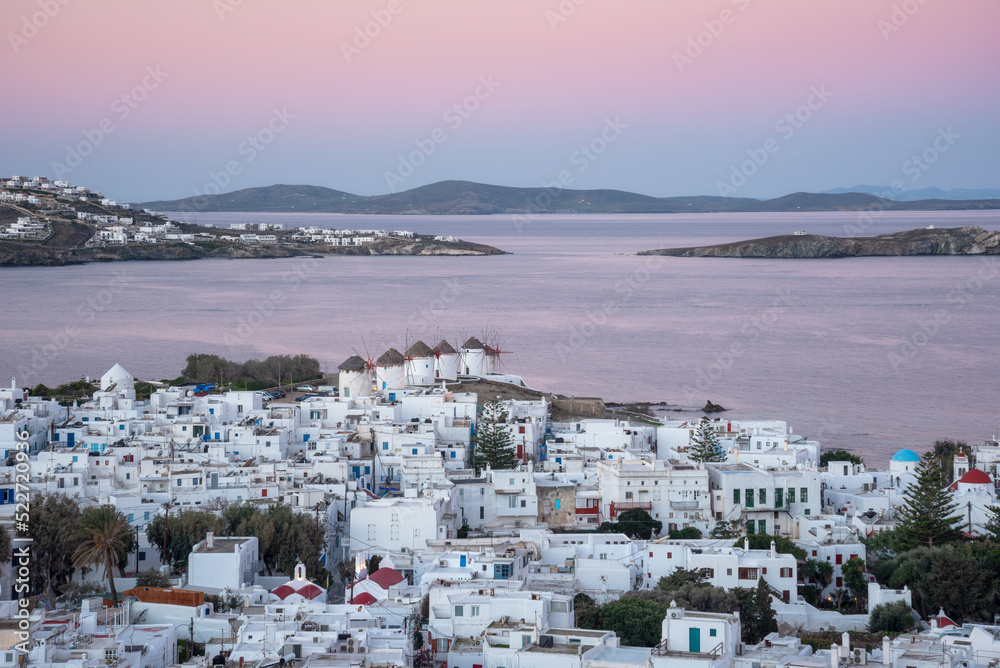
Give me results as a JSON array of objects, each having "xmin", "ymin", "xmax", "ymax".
[{"xmin": 0, "ymin": 0, "xmax": 1000, "ymax": 201}]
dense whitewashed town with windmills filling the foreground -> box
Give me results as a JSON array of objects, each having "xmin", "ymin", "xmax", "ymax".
[{"xmin": 0, "ymin": 342, "xmax": 1000, "ymax": 668}]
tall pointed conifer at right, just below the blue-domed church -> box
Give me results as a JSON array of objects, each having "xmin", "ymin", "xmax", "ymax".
[{"xmin": 899, "ymin": 452, "xmax": 962, "ymax": 547}]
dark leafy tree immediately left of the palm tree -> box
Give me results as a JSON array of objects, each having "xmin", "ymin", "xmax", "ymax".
[{"xmin": 25, "ymin": 494, "xmax": 81, "ymax": 607}]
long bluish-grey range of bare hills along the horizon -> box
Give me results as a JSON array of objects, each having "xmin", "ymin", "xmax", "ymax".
[{"xmin": 141, "ymin": 181, "xmax": 1000, "ymax": 215}]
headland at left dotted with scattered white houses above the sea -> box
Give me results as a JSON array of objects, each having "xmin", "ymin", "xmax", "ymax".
[{"xmin": 0, "ymin": 175, "xmax": 500, "ymax": 264}]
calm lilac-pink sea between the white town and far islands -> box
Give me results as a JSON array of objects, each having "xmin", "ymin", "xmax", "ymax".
[{"xmin": 0, "ymin": 212, "xmax": 1000, "ymax": 463}]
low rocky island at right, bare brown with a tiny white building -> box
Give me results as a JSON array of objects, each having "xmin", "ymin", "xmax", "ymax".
[{"xmin": 639, "ymin": 226, "xmax": 1000, "ymax": 258}]
